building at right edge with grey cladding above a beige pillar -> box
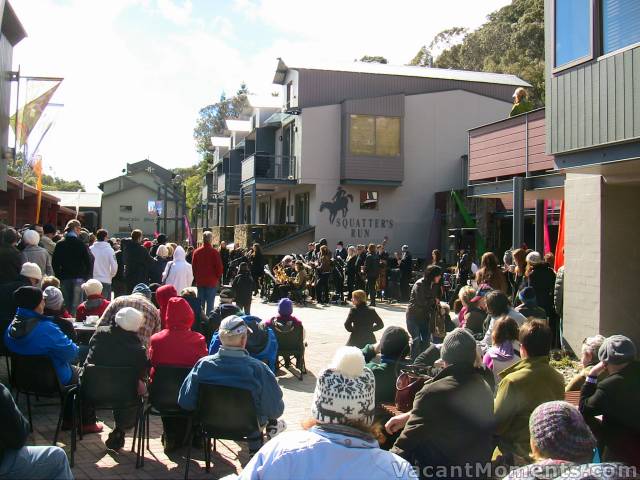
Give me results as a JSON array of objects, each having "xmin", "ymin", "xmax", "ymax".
[{"xmin": 545, "ymin": 0, "xmax": 640, "ymax": 351}]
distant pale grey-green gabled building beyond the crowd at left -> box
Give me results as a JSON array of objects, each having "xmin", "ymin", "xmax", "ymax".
[{"xmin": 99, "ymin": 160, "xmax": 186, "ymax": 241}]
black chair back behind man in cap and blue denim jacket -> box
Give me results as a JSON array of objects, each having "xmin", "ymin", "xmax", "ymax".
[{"xmin": 197, "ymin": 383, "xmax": 261, "ymax": 440}]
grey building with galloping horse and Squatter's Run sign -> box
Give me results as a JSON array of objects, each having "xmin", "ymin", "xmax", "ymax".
[{"xmin": 208, "ymin": 60, "xmax": 528, "ymax": 257}]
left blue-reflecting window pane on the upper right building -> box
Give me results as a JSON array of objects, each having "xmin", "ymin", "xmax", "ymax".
[{"xmin": 554, "ymin": 0, "xmax": 592, "ymax": 68}]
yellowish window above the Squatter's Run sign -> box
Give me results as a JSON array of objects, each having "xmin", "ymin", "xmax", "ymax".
[{"xmin": 349, "ymin": 115, "xmax": 400, "ymax": 157}]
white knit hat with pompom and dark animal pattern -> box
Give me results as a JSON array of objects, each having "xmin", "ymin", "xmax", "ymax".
[{"xmin": 311, "ymin": 347, "xmax": 376, "ymax": 425}]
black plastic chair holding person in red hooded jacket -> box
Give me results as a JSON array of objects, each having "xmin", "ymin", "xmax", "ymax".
[{"xmin": 144, "ymin": 365, "xmax": 191, "ymax": 450}]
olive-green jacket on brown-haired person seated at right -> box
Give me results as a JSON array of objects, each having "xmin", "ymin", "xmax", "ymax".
[{"xmin": 494, "ymin": 356, "xmax": 564, "ymax": 460}]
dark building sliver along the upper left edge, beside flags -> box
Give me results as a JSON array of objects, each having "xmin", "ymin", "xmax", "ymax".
[{"xmin": 0, "ymin": 0, "xmax": 27, "ymax": 191}]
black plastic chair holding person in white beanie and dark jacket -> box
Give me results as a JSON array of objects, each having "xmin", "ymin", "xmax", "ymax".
[{"xmin": 80, "ymin": 365, "xmax": 145, "ymax": 468}]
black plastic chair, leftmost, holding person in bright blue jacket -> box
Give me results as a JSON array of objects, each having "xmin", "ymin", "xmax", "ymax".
[{"xmin": 10, "ymin": 354, "xmax": 82, "ymax": 467}]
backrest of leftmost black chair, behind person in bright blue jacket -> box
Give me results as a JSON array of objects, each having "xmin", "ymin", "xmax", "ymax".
[{"xmin": 11, "ymin": 353, "xmax": 62, "ymax": 397}]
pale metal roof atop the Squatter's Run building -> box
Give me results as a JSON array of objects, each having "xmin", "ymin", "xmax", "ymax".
[{"xmin": 273, "ymin": 59, "xmax": 531, "ymax": 87}]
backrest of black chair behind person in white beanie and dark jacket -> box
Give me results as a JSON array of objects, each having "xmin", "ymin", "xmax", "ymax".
[{"xmin": 80, "ymin": 365, "xmax": 140, "ymax": 409}]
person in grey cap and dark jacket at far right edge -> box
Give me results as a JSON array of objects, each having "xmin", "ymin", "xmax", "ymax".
[{"xmin": 580, "ymin": 335, "xmax": 640, "ymax": 468}]
